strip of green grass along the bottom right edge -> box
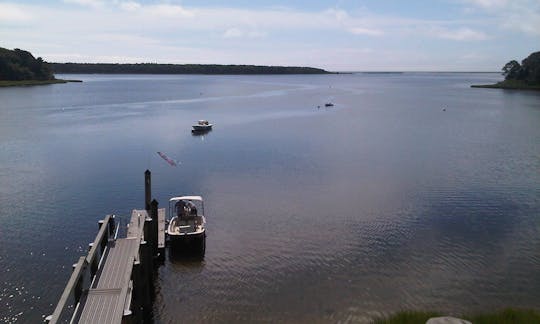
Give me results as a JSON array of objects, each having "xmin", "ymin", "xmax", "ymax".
[{"xmin": 373, "ymin": 308, "xmax": 540, "ymax": 324}]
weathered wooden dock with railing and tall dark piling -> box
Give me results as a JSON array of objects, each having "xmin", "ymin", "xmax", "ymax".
[{"xmin": 47, "ymin": 170, "xmax": 166, "ymax": 324}]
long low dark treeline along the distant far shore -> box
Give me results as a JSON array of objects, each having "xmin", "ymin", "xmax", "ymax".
[{"xmin": 50, "ymin": 63, "xmax": 330, "ymax": 74}]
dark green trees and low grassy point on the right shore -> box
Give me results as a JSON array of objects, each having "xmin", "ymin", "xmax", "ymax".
[{"xmin": 471, "ymin": 52, "xmax": 540, "ymax": 91}]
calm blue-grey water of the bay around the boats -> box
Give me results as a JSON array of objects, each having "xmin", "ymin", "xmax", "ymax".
[{"xmin": 0, "ymin": 73, "xmax": 540, "ymax": 323}]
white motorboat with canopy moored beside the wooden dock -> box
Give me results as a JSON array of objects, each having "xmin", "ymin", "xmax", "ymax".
[{"xmin": 167, "ymin": 196, "xmax": 206, "ymax": 255}]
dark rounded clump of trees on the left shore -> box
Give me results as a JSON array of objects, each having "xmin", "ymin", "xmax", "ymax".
[{"xmin": 0, "ymin": 47, "xmax": 54, "ymax": 81}]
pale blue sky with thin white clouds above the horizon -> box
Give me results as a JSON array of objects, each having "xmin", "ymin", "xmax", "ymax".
[{"xmin": 0, "ymin": 0, "xmax": 540, "ymax": 71}]
